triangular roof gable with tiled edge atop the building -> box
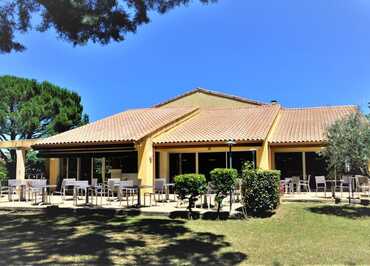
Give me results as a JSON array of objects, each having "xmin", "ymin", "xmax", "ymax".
[{"xmin": 155, "ymin": 88, "xmax": 264, "ymax": 108}]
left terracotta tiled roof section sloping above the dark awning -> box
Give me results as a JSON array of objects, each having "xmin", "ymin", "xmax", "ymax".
[{"xmin": 34, "ymin": 108, "xmax": 196, "ymax": 147}]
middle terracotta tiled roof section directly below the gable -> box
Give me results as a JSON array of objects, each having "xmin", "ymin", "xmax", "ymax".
[{"xmin": 154, "ymin": 105, "xmax": 280, "ymax": 144}]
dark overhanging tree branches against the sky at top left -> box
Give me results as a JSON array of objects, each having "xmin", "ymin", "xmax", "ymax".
[{"xmin": 0, "ymin": 0, "xmax": 217, "ymax": 53}]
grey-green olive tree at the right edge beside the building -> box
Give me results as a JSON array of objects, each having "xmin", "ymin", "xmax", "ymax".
[{"xmin": 322, "ymin": 113, "xmax": 370, "ymax": 176}]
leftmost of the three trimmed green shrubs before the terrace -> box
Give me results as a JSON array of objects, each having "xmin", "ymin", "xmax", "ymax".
[{"xmin": 175, "ymin": 174, "xmax": 207, "ymax": 217}]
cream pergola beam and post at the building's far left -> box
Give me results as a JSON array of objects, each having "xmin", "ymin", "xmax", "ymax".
[{"xmin": 0, "ymin": 139, "xmax": 40, "ymax": 179}]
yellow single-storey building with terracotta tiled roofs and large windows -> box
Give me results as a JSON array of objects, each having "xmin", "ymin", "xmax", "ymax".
[{"xmin": 32, "ymin": 88, "xmax": 358, "ymax": 189}]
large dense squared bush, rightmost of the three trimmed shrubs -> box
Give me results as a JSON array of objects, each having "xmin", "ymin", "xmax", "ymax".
[{"xmin": 242, "ymin": 164, "xmax": 280, "ymax": 215}]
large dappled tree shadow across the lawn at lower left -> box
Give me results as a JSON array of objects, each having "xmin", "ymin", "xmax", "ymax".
[{"xmin": 0, "ymin": 209, "xmax": 247, "ymax": 265}]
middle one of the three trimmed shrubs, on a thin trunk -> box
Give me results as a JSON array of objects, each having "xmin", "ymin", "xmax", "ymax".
[{"xmin": 210, "ymin": 168, "xmax": 238, "ymax": 218}]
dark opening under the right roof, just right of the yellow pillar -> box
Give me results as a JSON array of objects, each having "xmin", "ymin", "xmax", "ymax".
[{"xmin": 275, "ymin": 152, "xmax": 303, "ymax": 179}]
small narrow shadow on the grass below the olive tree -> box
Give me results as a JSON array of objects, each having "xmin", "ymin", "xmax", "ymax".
[{"xmin": 307, "ymin": 205, "xmax": 370, "ymax": 219}]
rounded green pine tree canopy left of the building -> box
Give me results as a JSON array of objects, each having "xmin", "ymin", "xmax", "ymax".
[{"xmin": 0, "ymin": 76, "xmax": 88, "ymax": 165}]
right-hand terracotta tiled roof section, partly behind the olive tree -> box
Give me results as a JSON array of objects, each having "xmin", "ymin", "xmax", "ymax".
[{"xmin": 270, "ymin": 105, "xmax": 358, "ymax": 144}]
